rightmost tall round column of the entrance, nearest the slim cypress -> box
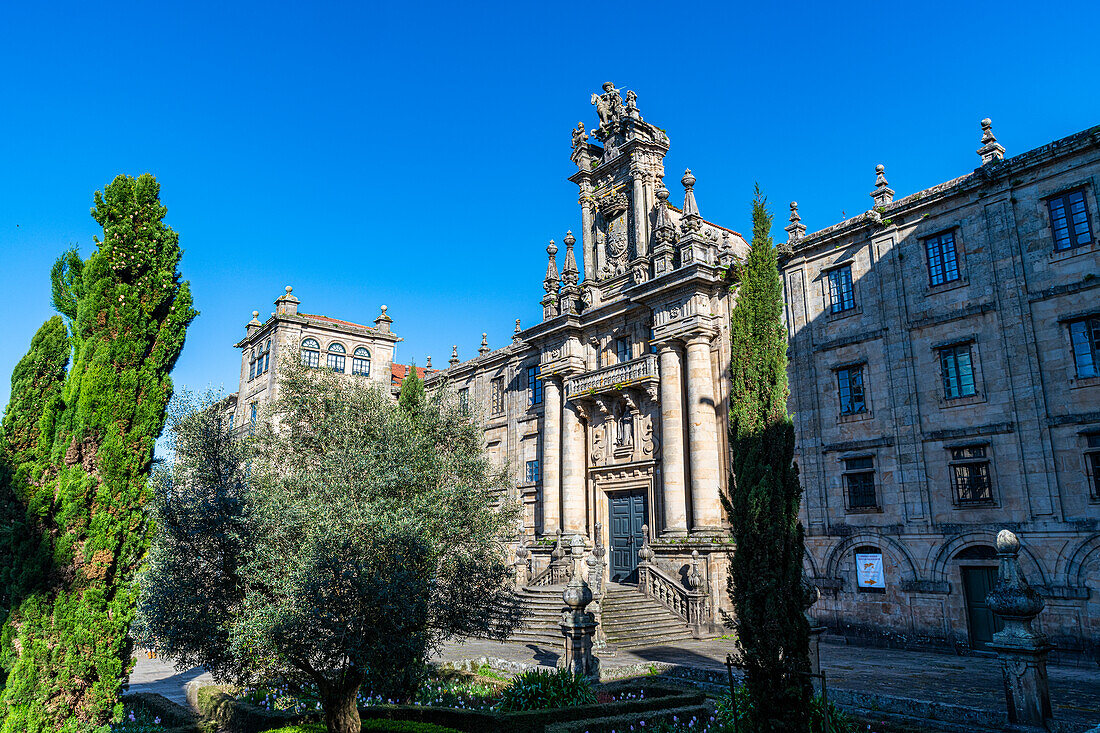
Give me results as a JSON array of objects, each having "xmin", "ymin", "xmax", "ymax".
[{"xmin": 688, "ymin": 336, "xmax": 722, "ymax": 532}]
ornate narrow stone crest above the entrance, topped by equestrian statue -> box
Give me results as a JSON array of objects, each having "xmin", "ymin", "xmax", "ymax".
[{"xmin": 570, "ymin": 81, "xmax": 669, "ymax": 306}]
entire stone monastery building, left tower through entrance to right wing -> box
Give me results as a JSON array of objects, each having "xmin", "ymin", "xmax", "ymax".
[{"xmin": 226, "ymin": 84, "xmax": 1100, "ymax": 650}]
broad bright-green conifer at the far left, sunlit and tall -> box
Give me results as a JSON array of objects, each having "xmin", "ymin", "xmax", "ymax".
[{"xmin": 0, "ymin": 174, "xmax": 196, "ymax": 733}]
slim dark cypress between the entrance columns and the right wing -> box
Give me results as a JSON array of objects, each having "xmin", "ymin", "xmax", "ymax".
[{"xmin": 723, "ymin": 186, "xmax": 811, "ymax": 732}]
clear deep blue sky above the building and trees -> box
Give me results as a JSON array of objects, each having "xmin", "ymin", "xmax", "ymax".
[{"xmin": 0, "ymin": 2, "xmax": 1100, "ymax": 404}]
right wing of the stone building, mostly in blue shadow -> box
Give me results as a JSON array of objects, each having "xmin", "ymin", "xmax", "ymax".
[{"xmin": 783, "ymin": 120, "xmax": 1100, "ymax": 650}]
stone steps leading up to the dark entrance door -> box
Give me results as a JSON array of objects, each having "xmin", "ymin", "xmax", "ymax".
[{"xmin": 509, "ymin": 583, "xmax": 692, "ymax": 649}]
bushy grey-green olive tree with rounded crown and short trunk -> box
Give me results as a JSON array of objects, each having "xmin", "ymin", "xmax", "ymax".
[{"xmin": 141, "ymin": 359, "xmax": 521, "ymax": 731}]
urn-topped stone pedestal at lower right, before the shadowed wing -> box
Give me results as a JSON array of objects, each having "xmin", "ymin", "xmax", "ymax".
[{"xmin": 986, "ymin": 529, "xmax": 1054, "ymax": 731}]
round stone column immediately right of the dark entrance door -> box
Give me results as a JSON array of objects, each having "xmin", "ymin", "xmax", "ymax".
[{"xmin": 658, "ymin": 342, "xmax": 688, "ymax": 535}]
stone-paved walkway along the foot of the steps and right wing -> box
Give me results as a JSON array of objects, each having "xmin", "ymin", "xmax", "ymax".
[{"xmin": 440, "ymin": 639, "xmax": 1100, "ymax": 730}]
